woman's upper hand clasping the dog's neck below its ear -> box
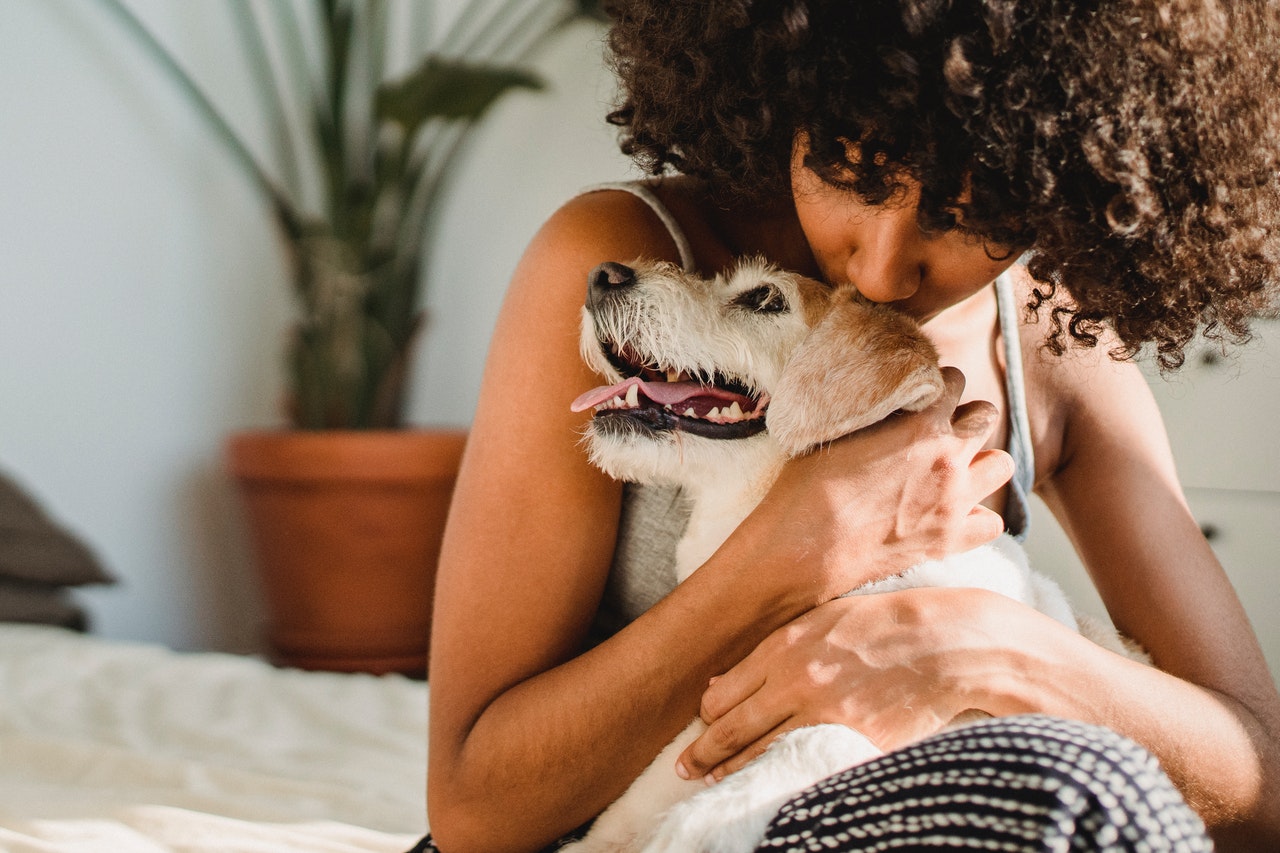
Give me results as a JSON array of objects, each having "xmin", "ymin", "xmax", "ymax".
[{"xmin": 735, "ymin": 368, "xmax": 1014, "ymax": 610}]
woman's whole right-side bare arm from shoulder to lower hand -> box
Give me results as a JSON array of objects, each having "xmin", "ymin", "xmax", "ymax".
[{"xmin": 681, "ymin": 325, "xmax": 1280, "ymax": 849}]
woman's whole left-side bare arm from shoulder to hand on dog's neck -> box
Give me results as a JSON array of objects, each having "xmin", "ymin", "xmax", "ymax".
[{"xmin": 428, "ymin": 193, "xmax": 1009, "ymax": 853}]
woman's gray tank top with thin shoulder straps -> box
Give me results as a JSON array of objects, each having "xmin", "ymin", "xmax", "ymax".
[{"xmin": 588, "ymin": 182, "xmax": 1036, "ymax": 642}]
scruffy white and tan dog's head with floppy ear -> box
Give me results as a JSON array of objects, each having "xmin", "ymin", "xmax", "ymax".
[{"xmin": 573, "ymin": 260, "xmax": 942, "ymax": 483}]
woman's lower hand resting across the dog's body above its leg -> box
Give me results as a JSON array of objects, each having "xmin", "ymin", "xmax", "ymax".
[{"xmin": 677, "ymin": 588, "xmax": 1034, "ymax": 780}]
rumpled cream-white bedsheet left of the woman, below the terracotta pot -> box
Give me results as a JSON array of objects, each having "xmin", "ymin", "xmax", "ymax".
[{"xmin": 0, "ymin": 625, "xmax": 426, "ymax": 853}]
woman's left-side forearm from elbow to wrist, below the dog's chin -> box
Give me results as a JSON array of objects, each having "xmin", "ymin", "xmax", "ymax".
[{"xmin": 428, "ymin": 537, "xmax": 801, "ymax": 853}]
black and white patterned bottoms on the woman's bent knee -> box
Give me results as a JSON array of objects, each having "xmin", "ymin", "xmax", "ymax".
[{"xmin": 411, "ymin": 716, "xmax": 1213, "ymax": 853}]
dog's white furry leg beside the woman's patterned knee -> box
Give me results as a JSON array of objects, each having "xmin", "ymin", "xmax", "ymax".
[{"xmin": 644, "ymin": 725, "xmax": 881, "ymax": 853}]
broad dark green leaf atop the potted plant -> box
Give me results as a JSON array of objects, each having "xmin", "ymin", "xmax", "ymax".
[{"xmin": 376, "ymin": 56, "xmax": 543, "ymax": 136}]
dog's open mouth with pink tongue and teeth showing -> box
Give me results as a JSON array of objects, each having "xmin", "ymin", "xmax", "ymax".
[{"xmin": 572, "ymin": 343, "xmax": 769, "ymax": 438}]
